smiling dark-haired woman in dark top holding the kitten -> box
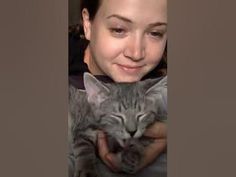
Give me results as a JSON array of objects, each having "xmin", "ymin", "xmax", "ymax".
[{"xmin": 70, "ymin": 0, "xmax": 167, "ymax": 174}]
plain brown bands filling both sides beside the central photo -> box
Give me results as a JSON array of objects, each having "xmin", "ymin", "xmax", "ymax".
[{"xmin": 0, "ymin": 0, "xmax": 236, "ymax": 177}]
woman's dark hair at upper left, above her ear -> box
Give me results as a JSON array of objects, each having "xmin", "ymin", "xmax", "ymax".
[{"xmin": 80, "ymin": 0, "xmax": 102, "ymax": 21}]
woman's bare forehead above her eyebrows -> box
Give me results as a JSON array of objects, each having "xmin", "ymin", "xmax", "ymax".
[{"xmin": 97, "ymin": 0, "xmax": 167, "ymax": 23}]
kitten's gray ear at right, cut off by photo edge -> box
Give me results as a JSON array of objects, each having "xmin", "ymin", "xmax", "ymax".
[{"xmin": 145, "ymin": 76, "xmax": 167, "ymax": 109}]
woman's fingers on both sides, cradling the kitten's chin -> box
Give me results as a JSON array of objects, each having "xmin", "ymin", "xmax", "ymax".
[{"xmin": 98, "ymin": 122, "xmax": 167, "ymax": 171}]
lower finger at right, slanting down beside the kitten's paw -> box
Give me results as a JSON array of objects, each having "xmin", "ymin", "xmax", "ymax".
[{"xmin": 139, "ymin": 139, "xmax": 167, "ymax": 169}]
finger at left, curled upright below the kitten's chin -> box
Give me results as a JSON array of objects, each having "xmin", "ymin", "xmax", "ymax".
[{"xmin": 98, "ymin": 131, "xmax": 118, "ymax": 171}]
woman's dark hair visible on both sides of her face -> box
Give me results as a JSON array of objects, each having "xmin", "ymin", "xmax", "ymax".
[{"xmin": 79, "ymin": 0, "xmax": 167, "ymax": 75}]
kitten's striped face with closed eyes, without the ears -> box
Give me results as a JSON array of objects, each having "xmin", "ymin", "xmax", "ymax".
[{"xmin": 96, "ymin": 87, "xmax": 158, "ymax": 139}]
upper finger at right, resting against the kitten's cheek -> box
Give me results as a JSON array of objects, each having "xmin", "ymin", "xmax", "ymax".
[{"xmin": 144, "ymin": 122, "xmax": 167, "ymax": 139}]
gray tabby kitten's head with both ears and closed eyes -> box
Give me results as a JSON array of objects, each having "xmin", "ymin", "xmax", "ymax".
[{"xmin": 85, "ymin": 72, "xmax": 166, "ymax": 144}]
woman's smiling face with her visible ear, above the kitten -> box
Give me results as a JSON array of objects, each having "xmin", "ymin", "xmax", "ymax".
[{"xmin": 82, "ymin": 0, "xmax": 167, "ymax": 82}]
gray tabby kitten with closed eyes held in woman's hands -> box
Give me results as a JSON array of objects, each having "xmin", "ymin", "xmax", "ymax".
[{"xmin": 68, "ymin": 73, "xmax": 167, "ymax": 177}]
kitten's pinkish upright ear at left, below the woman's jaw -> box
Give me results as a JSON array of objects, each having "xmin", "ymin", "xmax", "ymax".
[{"xmin": 84, "ymin": 72, "xmax": 110, "ymax": 106}]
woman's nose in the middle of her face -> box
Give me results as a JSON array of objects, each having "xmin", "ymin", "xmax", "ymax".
[{"xmin": 124, "ymin": 37, "xmax": 145, "ymax": 61}]
